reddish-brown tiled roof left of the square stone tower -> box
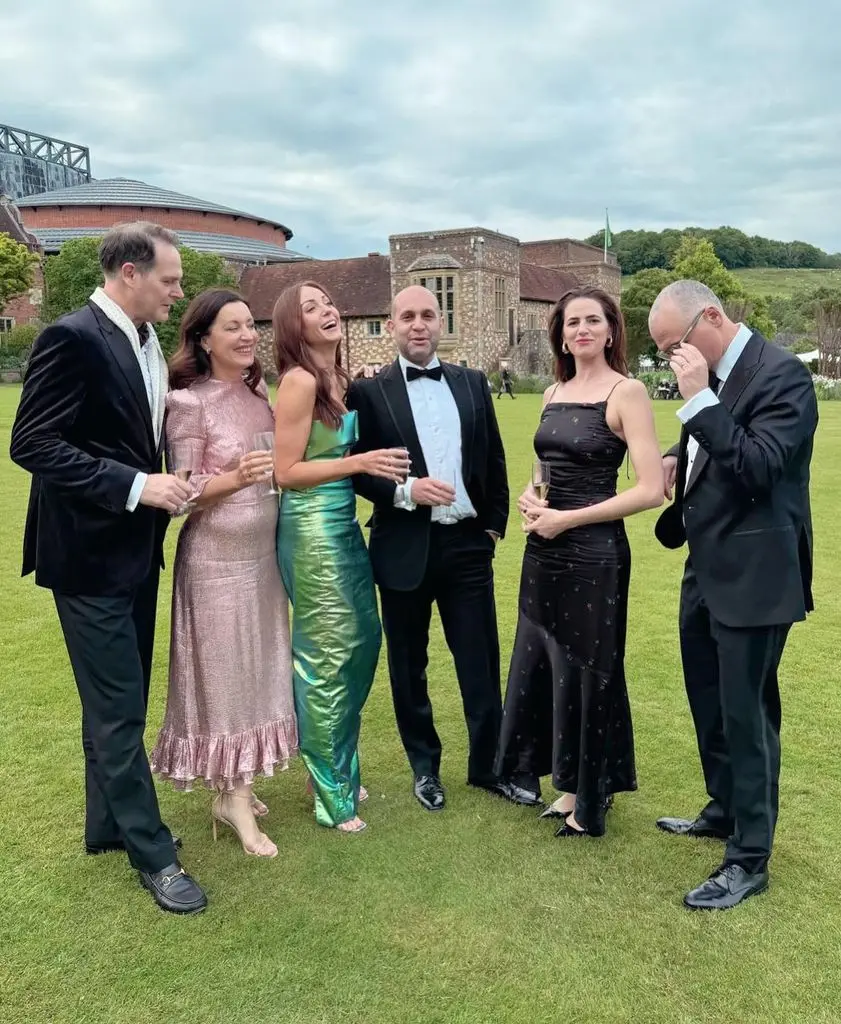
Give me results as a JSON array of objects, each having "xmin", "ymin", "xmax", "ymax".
[{"xmin": 240, "ymin": 256, "xmax": 391, "ymax": 322}]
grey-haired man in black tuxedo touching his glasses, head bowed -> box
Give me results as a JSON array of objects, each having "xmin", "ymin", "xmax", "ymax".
[{"xmin": 648, "ymin": 281, "xmax": 817, "ymax": 909}]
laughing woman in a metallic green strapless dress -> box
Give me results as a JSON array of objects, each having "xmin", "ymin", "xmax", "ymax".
[{"xmin": 272, "ymin": 282, "xmax": 409, "ymax": 833}]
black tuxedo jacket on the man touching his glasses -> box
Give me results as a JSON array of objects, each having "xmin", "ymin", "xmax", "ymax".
[{"xmin": 655, "ymin": 333, "xmax": 817, "ymax": 627}]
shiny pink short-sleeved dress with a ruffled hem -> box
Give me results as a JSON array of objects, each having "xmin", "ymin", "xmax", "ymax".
[{"xmin": 150, "ymin": 379, "xmax": 298, "ymax": 790}]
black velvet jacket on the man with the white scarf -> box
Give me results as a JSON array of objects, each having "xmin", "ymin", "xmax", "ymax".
[{"xmin": 11, "ymin": 303, "xmax": 169, "ymax": 596}]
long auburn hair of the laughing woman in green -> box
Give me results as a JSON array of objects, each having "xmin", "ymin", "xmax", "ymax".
[{"xmin": 271, "ymin": 281, "xmax": 350, "ymax": 429}]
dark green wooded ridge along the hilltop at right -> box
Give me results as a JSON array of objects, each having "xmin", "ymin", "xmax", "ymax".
[{"xmin": 586, "ymin": 227, "xmax": 841, "ymax": 274}]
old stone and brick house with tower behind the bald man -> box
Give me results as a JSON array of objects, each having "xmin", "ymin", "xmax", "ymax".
[{"xmin": 241, "ymin": 227, "xmax": 621, "ymax": 374}]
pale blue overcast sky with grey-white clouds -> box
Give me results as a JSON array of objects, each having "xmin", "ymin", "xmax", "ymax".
[{"xmin": 0, "ymin": 0, "xmax": 841, "ymax": 258}]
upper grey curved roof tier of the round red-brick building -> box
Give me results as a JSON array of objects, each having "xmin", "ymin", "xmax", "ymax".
[{"xmin": 17, "ymin": 178, "xmax": 292, "ymax": 240}]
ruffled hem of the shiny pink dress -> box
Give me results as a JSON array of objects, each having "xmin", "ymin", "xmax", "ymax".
[{"xmin": 150, "ymin": 718, "xmax": 298, "ymax": 793}]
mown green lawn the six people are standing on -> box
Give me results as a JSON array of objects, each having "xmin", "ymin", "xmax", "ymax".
[{"xmin": 0, "ymin": 387, "xmax": 841, "ymax": 1024}]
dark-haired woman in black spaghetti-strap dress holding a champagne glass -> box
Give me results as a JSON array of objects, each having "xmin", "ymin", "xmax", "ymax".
[{"xmin": 496, "ymin": 287, "xmax": 664, "ymax": 837}]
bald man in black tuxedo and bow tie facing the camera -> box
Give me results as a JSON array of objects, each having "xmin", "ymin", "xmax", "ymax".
[{"xmin": 347, "ymin": 286, "xmax": 509, "ymax": 811}]
